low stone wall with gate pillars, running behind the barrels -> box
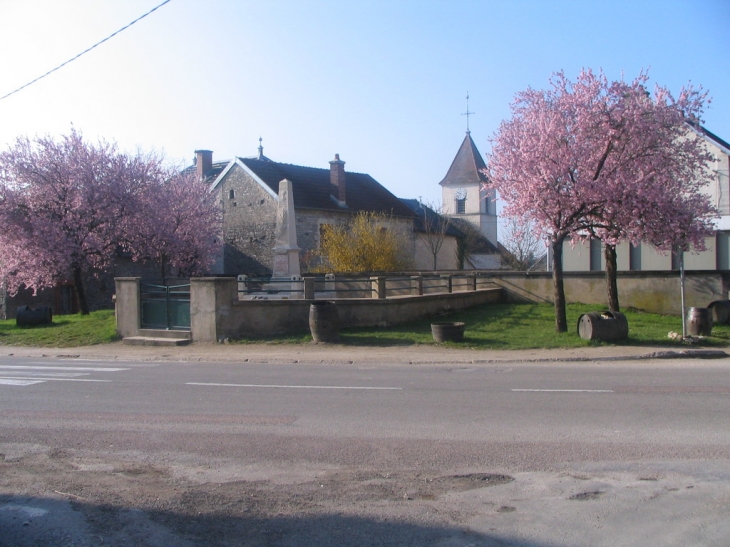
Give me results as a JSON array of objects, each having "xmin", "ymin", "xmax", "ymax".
[{"xmin": 116, "ymin": 271, "xmax": 730, "ymax": 342}]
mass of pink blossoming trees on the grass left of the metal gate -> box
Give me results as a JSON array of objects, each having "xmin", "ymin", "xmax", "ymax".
[{"xmin": 0, "ymin": 130, "xmax": 218, "ymax": 314}]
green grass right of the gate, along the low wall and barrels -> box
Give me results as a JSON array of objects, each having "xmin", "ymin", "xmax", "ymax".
[{"xmin": 232, "ymin": 304, "xmax": 730, "ymax": 350}]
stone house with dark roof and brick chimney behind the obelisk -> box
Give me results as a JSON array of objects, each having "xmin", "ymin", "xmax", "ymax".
[{"xmin": 189, "ymin": 146, "xmax": 416, "ymax": 276}]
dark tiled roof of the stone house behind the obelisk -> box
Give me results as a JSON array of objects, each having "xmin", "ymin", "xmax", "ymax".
[{"xmin": 238, "ymin": 158, "xmax": 415, "ymax": 217}]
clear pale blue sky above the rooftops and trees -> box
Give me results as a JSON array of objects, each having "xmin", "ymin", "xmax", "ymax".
[{"xmin": 0, "ymin": 0, "xmax": 730, "ymax": 225}]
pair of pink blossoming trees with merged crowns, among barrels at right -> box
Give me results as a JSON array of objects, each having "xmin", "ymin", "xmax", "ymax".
[{"xmin": 488, "ymin": 70, "xmax": 711, "ymax": 332}]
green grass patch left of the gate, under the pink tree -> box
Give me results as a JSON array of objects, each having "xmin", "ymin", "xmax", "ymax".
[{"xmin": 0, "ymin": 310, "xmax": 119, "ymax": 348}]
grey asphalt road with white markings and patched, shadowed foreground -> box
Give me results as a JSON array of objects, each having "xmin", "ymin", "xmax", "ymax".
[{"xmin": 0, "ymin": 356, "xmax": 730, "ymax": 547}]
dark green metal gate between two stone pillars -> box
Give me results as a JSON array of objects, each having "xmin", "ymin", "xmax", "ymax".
[{"xmin": 140, "ymin": 283, "xmax": 190, "ymax": 330}]
